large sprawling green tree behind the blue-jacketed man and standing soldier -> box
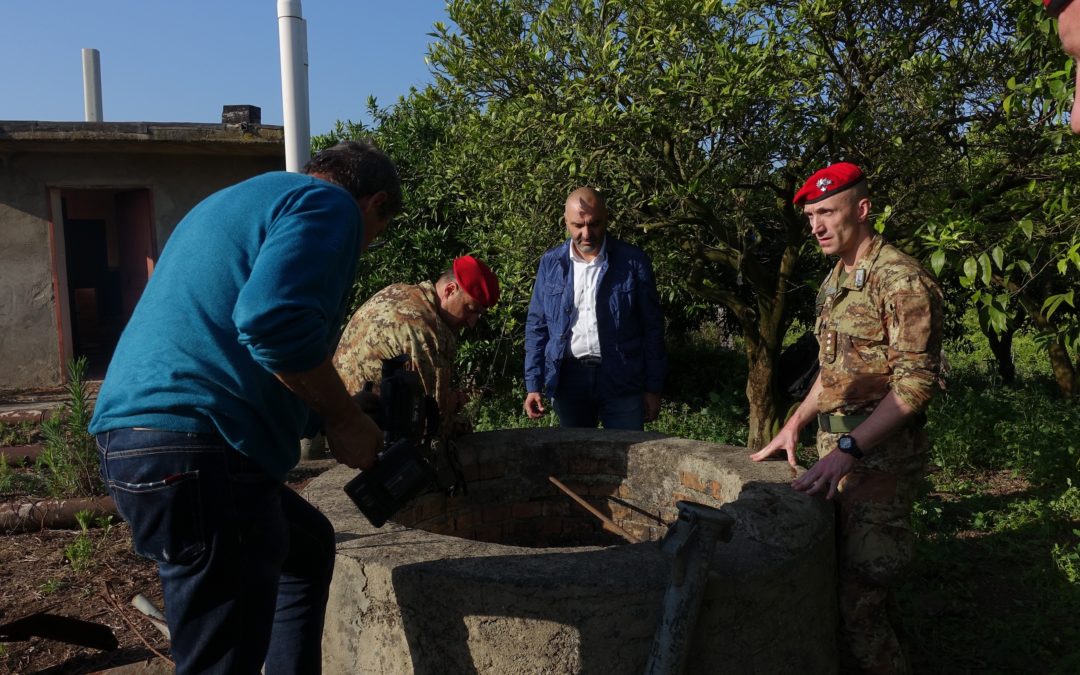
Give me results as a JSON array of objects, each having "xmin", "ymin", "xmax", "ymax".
[{"xmin": 334, "ymin": 0, "xmax": 1045, "ymax": 443}]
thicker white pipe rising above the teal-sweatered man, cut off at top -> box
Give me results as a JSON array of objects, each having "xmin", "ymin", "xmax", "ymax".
[{"xmin": 278, "ymin": 0, "xmax": 311, "ymax": 172}]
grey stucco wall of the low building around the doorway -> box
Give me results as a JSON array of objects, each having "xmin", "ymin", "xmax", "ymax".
[{"xmin": 0, "ymin": 146, "xmax": 284, "ymax": 391}]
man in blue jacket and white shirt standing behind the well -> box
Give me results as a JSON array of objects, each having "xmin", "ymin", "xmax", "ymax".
[{"xmin": 525, "ymin": 187, "xmax": 667, "ymax": 429}]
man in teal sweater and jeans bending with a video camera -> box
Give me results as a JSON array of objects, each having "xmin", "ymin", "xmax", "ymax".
[{"xmin": 90, "ymin": 141, "xmax": 401, "ymax": 674}]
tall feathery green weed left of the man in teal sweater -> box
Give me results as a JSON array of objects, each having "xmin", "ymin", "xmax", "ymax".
[{"xmin": 38, "ymin": 357, "xmax": 105, "ymax": 497}]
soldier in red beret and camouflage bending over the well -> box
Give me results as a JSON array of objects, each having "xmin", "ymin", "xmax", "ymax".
[{"xmin": 334, "ymin": 256, "xmax": 499, "ymax": 435}]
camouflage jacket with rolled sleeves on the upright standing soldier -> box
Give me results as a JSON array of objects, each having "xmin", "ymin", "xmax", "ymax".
[{"xmin": 814, "ymin": 237, "xmax": 943, "ymax": 415}]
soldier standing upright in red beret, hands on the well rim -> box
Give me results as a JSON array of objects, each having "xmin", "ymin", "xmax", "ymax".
[{"xmin": 752, "ymin": 163, "xmax": 943, "ymax": 673}]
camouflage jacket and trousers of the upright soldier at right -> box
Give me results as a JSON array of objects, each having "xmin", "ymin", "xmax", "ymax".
[{"xmin": 815, "ymin": 237, "xmax": 943, "ymax": 673}]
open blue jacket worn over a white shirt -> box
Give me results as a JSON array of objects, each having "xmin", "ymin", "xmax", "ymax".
[{"xmin": 525, "ymin": 234, "xmax": 667, "ymax": 396}]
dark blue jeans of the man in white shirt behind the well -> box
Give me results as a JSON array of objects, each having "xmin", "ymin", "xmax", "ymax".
[{"xmin": 552, "ymin": 359, "xmax": 645, "ymax": 431}]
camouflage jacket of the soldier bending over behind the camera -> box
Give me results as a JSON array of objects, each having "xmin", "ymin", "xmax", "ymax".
[{"xmin": 334, "ymin": 282, "xmax": 458, "ymax": 430}]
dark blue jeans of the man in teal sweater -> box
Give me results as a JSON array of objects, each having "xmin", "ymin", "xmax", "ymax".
[{"xmin": 97, "ymin": 429, "xmax": 335, "ymax": 675}]
